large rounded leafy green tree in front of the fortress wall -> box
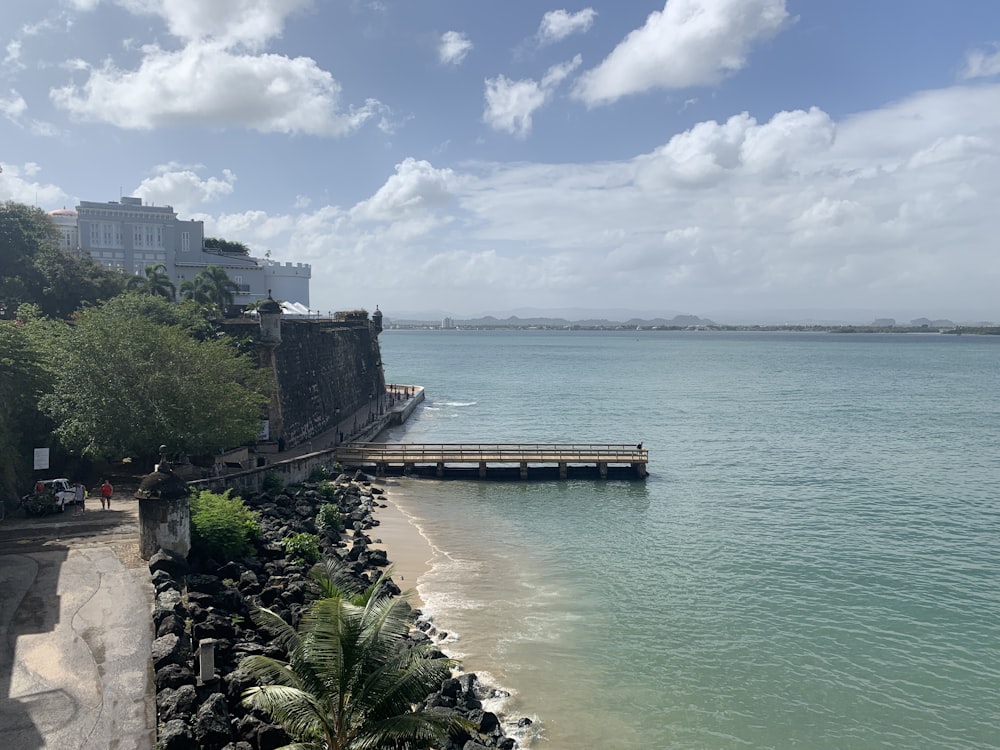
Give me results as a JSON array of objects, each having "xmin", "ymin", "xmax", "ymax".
[{"xmin": 42, "ymin": 295, "xmax": 269, "ymax": 458}]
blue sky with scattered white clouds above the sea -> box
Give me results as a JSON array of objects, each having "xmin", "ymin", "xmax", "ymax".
[{"xmin": 0, "ymin": 0, "xmax": 1000, "ymax": 321}]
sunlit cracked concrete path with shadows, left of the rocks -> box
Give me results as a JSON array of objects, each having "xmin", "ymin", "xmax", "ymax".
[{"xmin": 0, "ymin": 496, "xmax": 156, "ymax": 750}]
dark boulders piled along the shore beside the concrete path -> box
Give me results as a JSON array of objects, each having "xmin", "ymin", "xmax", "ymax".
[{"xmin": 149, "ymin": 472, "xmax": 531, "ymax": 750}]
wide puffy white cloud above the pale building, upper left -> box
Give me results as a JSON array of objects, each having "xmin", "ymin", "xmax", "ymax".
[{"xmin": 50, "ymin": 43, "xmax": 385, "ymax": 136}]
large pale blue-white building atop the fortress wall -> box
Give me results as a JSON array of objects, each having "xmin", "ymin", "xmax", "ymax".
[{"xmin": 49, "ymin": 198, "xmax": 312, "ymax": 308}]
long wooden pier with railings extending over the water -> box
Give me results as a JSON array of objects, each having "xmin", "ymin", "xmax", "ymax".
[{"xmin": 335, "ymin": 443, "xmax": 649, "ymax": 479}]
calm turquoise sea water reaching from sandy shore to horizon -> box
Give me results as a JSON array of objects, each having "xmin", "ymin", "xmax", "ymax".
[{"xmin": 381, "ymin": 330, "xmax": 1000, "ymax": 750}]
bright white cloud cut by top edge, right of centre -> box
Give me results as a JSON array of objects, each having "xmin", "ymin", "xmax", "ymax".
[{"xmin": 574, "ymin": 0, "xmax": 789, "ymax": 106}]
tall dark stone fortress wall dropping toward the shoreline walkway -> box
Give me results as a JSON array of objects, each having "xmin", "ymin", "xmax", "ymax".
[{"xmin": 226, "ymin": 318, "xmax": 385, "ymax": 447}]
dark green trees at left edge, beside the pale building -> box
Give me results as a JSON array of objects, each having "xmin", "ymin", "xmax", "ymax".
[{"xmin": 0, "ymin": 201, "xmax": 125, "ymax": 320}]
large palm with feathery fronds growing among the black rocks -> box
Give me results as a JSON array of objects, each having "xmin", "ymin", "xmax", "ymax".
[{"xmin": 240, "ymin": 560, "xmax": 470, "ymax": 750}]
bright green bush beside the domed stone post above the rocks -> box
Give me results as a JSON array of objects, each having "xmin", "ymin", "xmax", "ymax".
[{"xmin": 191, "ymin": 490, "xmax": 260, "ymax": 560}]
